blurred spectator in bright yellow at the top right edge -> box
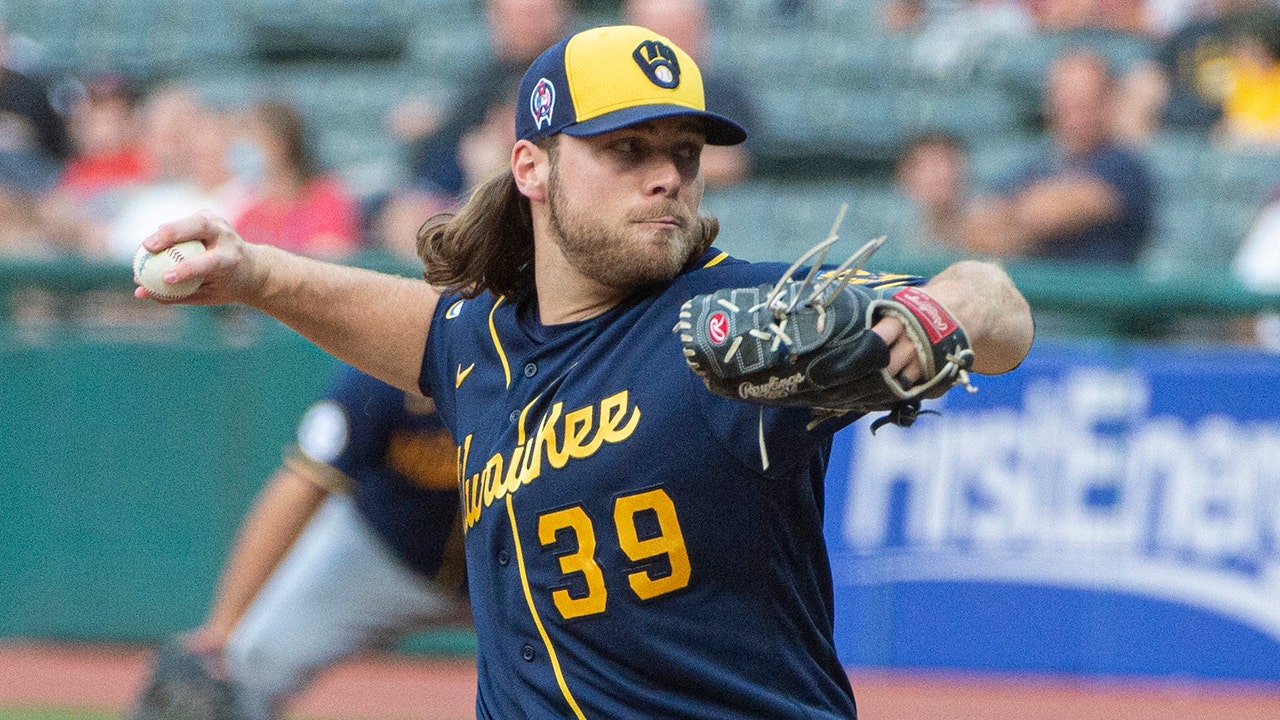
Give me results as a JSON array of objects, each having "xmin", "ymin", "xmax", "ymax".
[{"xmin": 1217, "ymin": 8, "xmax": 1280, "ymax": 146}]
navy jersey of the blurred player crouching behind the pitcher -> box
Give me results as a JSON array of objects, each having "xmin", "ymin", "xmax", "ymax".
[{"xmin": 288, "ymin": 365, "xmax": 463, "ymax": 588}]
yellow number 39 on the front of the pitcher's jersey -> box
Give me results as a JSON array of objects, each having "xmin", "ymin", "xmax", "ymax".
[{"xmin": 538, "ymin": 488, "xmax": 690, "ymax": 620}]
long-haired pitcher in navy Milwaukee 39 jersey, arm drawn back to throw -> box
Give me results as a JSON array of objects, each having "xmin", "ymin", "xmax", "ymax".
[{"xmin": 137, "ymin": 27, "xmax": 1032, "ymax": 719}]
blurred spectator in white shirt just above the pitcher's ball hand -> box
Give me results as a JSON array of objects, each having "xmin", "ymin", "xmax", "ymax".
[{"xmin": 102, "ymin": 85, "xmax": 248, "ymax": 260}]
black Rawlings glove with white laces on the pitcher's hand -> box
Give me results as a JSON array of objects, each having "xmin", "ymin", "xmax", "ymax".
[{"xmin": 675, "ymin": 219, "xmax": 974, "ymax": 432}]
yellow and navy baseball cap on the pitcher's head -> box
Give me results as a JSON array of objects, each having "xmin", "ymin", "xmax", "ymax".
[{"xmin": 516, "ymin": 26, "xmax": 746, "ymax": 145}]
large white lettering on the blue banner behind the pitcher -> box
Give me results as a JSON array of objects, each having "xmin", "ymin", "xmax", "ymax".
[{"xmin": 837, "ymin": 369, "xmax": 1280, "ymax": 641}]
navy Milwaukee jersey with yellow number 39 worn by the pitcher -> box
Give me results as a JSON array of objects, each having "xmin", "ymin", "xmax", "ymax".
[{"xmin": 421, "ymin": 244, "xmax": 915, "ymax": 720}]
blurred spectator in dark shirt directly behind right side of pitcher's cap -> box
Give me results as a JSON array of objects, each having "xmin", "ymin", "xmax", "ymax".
[{"xmin": 622, "ymin": 0, "xmax": 755, "ymax": 190}]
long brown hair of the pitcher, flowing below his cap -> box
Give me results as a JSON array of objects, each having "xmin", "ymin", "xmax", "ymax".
[{"xmin": 417, "ymin": 136, "xmax": 719, "ymax": 297}]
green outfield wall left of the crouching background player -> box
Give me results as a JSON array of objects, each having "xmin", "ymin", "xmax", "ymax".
[{"xmin": 0, "ymin": 312, "xmax": 333, "ymax": 639}]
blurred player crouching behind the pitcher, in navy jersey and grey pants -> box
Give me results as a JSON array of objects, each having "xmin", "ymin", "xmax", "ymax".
[{"xmin": 174, "ymin": 366, "xmax": 468, "ymax": 720}]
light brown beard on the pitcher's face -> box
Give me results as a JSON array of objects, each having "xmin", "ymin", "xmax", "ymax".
[{"xmin": 549, "ymin": 165, "xmax": 703, "ymax": 290}]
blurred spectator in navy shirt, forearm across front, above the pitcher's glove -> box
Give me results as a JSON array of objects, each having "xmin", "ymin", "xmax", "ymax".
[{"xmin": 964, "ymin": 51, "xmax": 1153, "ymax": 263}]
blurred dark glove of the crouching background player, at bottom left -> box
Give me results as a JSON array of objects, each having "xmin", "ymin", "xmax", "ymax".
[{"xmin": 129, "ymin": 638, "xmax": 244, "ymax": 720}]
